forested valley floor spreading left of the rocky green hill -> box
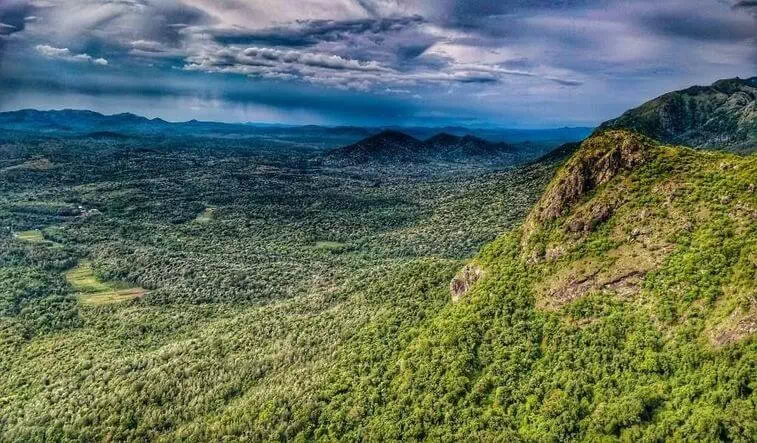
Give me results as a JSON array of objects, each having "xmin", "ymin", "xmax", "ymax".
[{"xmin": 0, "ymin": 139, "xmax": 555, "ymax": 441}]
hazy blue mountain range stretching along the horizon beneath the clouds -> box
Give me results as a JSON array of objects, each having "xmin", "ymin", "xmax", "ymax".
[{"xmin": 0, "ymin": 109, "xmax": 593, "ymax": 148}]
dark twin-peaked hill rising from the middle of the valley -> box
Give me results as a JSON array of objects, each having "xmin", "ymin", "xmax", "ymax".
[{"xmin": 326, "ymin": 130, "xmax": 520, "ymax": 165}]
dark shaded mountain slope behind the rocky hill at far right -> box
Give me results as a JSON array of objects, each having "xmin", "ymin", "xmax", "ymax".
[{"xmin": 598, "ymin": 77, "xmax": 757, "ymax": 152}]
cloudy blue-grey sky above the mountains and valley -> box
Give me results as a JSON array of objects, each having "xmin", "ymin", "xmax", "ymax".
[{"xmin": 0, "ymin": 0, "xmax": 757, "ymax": 128}]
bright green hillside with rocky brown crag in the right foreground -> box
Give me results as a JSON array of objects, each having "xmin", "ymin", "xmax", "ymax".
[{"xmin": 302, "ymin": 132, "xmax": 757, "ymax": 441}]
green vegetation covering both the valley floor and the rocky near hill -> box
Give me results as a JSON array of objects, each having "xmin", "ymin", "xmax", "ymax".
[{"xmin": 0, "ymin": 127, "xmax": 757, "ymax": 441}]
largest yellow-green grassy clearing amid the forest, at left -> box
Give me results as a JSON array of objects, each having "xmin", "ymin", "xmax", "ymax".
[{"xmin": 66, "ymin": 262, "xmax": 146, "ymax": 306}]
